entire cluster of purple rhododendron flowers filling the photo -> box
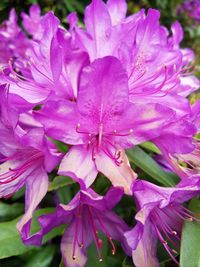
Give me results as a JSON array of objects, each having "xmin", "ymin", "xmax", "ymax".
[{"xmin": 0, "ymin": 0, "xmax": 200, "ymax": 267}]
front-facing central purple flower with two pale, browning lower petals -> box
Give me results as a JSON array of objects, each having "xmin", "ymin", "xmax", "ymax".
[{"xmin": 35, "ymin": 57, "xmax": 174, "ymax": 194}]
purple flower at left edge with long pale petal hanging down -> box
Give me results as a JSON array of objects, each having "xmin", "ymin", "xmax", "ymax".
[{"xmin": 0, "ymin": 86, "xmax": 61, "ymax": 236}]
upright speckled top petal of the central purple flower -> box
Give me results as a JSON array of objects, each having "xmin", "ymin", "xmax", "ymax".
[{"xmin": 77, "ymin": 56, "xmax": 128, "ymax": 123}]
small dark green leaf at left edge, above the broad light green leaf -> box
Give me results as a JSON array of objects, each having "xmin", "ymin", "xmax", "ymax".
[{"xmin": 0, "ymin": 202, "xmax": 24, "ymax": 222}]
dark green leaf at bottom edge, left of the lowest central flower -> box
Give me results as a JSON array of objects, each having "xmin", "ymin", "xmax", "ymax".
[{"xmin": 25, "ymin": 245, "xmax": 57, "ymax": 267}]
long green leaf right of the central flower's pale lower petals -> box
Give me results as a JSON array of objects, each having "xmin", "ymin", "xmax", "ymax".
[{"xmin": 127, "ymin": 146, "xmax": 178, "ymax": 186}]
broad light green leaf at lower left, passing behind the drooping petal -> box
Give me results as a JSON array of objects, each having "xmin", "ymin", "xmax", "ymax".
[{"xmin": 0, "ymin": 208, "xmax": 65, "ymax": 259}]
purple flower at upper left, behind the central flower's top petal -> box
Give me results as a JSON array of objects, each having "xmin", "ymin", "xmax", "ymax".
[{"xmin": 2, "ymin": 11, "xmax": 88, "ymax": 104}]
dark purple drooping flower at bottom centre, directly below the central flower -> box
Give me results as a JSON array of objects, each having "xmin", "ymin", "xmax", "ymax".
[{"xmin": 22, "ymin": 188, "xmax": 130, "ymax": 267}]
